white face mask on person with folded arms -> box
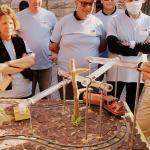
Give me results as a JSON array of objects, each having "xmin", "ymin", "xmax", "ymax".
[{"xmin": 126, "ymin": 1, "xmax": 142, "ymax": 14}]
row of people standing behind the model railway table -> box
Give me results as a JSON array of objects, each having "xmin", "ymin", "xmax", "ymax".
[{"xmin": 0, "ymin": 0, "xmax": 150, "ymax": 138}]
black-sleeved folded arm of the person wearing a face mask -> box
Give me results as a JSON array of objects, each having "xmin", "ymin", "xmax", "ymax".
[{"xmin": 107, "ymin": 17, "xmax": 150, "ymax": 56}]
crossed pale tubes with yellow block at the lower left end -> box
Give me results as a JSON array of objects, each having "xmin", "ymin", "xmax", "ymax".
[{"xmin": 14, "ymin": 58, "xmax": 119, "ymax": 123}]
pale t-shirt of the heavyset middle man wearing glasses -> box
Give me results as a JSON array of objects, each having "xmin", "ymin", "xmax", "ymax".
[{"xmin": 51, "ymin": 14, "xmax": 105, "ymax": 71}]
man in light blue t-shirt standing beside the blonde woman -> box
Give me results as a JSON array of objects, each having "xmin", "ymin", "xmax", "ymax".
[{"xmin": 17, "ymin": 0, "xmax": 57, "ymax": 95}]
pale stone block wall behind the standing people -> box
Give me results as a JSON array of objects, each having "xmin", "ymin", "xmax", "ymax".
[{"xmin": 0, "ymin": 0, "xmax": 75, "ymax": 18}]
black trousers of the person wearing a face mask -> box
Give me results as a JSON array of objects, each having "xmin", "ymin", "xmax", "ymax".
[{"xmin": 108, "ymin": 82, "xmax": 144, "ymax": 112}]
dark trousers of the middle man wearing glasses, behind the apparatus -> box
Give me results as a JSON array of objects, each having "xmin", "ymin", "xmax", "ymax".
[{"xmin": 57, "ymin": 75, "xmax": 83, "ymax": 100}]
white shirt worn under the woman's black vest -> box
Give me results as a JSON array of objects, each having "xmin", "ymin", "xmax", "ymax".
[{"xmin": 0, "ymin": 40, "xmax": 32, "ymax": 98}]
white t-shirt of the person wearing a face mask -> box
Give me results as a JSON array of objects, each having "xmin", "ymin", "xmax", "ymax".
[{"xmin": 107, "ymin": 13, "xmax": 150, "ymax": 82}]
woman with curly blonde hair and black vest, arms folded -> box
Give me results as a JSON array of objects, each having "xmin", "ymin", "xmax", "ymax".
[{"xmin": 0, "ymin": 5, "xmax": 34, "ymax": 98}]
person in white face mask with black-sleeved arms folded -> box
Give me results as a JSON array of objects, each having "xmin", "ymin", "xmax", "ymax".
[{"xmin": 107, "ymin": 0, "xmax": 150, "ymax": 111}]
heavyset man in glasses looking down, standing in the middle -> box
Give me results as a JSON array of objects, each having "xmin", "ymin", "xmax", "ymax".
[{"xmin": 49, "ymin": 0, "xmax": 105, "ymax": 99}]
